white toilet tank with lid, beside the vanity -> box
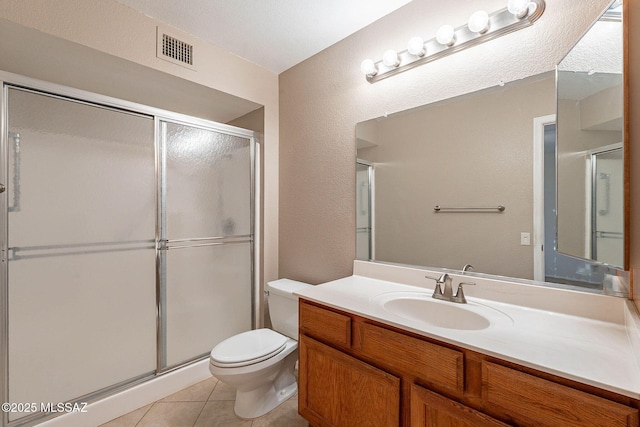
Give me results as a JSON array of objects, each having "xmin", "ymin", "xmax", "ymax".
[{"xmin": 266, "ymin": 279, "xmax": 312, "ymax": 340}]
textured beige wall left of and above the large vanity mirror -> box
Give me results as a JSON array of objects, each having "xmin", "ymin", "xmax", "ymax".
[{"xmin": 279, "ymin": 0, "xmax": 609, "ymax": 283}]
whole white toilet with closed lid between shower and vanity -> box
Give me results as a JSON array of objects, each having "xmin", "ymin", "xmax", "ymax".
[{"xmin": 209, "ymin": 279, "xmax": 311, "ymax": 419}]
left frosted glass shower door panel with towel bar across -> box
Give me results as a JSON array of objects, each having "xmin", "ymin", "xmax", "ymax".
[{"xmin": 3, "ymin": 87, "xmax": 156, "ymax": 420}]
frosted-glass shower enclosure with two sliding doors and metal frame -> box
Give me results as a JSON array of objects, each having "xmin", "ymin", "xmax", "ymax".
[{"xmin": 0, "ymin": 75, "xmax": 258, "ymax": 426}]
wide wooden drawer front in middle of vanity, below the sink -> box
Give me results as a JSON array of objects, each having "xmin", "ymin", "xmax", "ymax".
[{"xmin": 357, "ymin": 323, "xmax": 464, "ymax": 392}]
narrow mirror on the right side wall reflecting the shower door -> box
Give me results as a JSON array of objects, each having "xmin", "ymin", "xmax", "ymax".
[{"xmin": 557, "ymin": 1, "xmax": 625, "ymax": 274}]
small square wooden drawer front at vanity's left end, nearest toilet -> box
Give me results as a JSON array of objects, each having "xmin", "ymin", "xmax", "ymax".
[{"xmin": 299, "ymin": 301, "xmax": 351, "ymax": 348}]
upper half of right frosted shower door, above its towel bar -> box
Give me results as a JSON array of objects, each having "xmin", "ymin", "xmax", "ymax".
[{"xmin": 162, "ymin": 122, "xmax": 251, "ymax": 240}]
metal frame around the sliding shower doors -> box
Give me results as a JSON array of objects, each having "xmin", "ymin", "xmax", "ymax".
[{"xmin": 0, "ymin": 70, "xmax": 262, "ymax": 427}]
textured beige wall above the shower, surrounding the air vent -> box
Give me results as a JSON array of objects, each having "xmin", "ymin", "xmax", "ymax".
[{"xmin": 0, "ymin": 0, "xmax": 279, "ymax": 288}]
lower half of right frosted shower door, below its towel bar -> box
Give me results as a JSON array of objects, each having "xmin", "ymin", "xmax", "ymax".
[{"xmin": 166, "ymin": 243, "xmax": 251, "ymax": 366}]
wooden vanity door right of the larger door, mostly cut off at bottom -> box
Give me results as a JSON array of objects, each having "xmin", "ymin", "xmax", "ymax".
[{"xmin": 411, "ymin": 384, "xmax": 507, "ymax": 427}]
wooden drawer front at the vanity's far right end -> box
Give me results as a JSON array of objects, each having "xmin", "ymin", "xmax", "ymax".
[{"xmin": 482, "ymin": 361, "xmax": 638, "ymax": 427}]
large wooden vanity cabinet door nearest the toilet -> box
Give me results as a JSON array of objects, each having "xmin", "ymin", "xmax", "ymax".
[{"xmin": 298, "ymin": 335, "xmax": 400, "ymax": 427}]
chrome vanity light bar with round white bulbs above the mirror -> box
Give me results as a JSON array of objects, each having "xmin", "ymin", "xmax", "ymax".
[{"xmin": 360, "ymin": 0, "xmax": 545, "ymax": 83}]
